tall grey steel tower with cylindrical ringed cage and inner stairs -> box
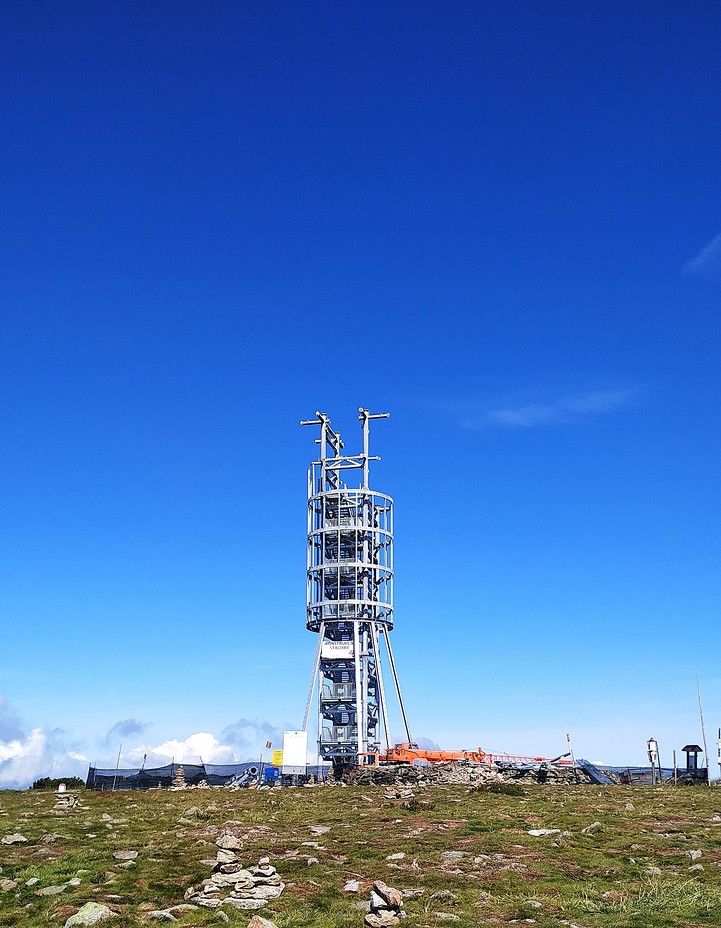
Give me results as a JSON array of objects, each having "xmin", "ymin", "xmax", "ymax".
[{"xmin": 301, "ymin": 407, "xmax": 411, "ymax": 765}]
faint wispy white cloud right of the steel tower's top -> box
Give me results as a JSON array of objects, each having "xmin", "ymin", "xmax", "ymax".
[{"xmin": 461, "ymin": 387, "xmax": 637, "ymax": 429}]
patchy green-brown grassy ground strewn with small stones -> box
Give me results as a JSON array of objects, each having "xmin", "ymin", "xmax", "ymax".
[{"xmin": 0, "ymin": 786, "xmax": 721, "ymax": 928}]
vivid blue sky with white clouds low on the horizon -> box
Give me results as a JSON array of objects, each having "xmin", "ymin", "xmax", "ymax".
[{"xmin": 0, "ymin": 0, "xmax": 721, "ymax": 784}]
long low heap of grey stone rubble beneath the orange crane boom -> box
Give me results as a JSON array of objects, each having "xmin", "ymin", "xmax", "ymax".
[{"xmin": 343, "ymin": 764, "xmax": 592, "ymax": 798}]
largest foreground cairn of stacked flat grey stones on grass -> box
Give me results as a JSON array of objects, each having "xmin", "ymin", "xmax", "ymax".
[{"xmin": 185, "ymin": 832, "xmax": 285, "ymax": 909}]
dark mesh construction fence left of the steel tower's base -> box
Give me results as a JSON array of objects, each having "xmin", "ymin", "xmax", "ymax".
[{"xmin": 86, "ymin": 761, "xmax": 328, "ymax": 790}]
